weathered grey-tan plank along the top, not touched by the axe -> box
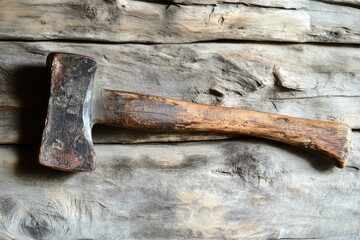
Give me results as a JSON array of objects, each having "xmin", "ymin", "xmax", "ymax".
[{"xmin": 0, "ymin": 0, "xmax": 360, "ymax": 44}]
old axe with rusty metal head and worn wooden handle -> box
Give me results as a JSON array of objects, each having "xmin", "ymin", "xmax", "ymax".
[{"xmin": 39, "ymin": 53, "xmax": 351, "ymax": 171}]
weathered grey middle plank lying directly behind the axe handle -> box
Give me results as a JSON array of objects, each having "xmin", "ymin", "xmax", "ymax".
[{"xmin": 0, "ymin": 42, "xmax": 360, "ymax": 143}]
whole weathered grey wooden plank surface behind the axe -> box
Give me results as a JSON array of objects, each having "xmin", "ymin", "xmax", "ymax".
[{"xmin": 0, "ymin": 0, "xmax": 360, "ymax": 239}]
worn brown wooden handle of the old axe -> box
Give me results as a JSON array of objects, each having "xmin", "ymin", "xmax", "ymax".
[{"xmin": 95, "ymin": 89, "xmax": 351, "ymax": 168}]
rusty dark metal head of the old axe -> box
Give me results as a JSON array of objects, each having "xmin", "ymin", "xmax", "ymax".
[{"xmin": 39, "ymin": 53, "xmax": 97, "ymax": 171}]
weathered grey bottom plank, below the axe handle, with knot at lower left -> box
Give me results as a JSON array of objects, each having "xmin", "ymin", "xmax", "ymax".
[{"xmin": 0, "ymin": 133, "xmax": 360, "ymax": 239}]
